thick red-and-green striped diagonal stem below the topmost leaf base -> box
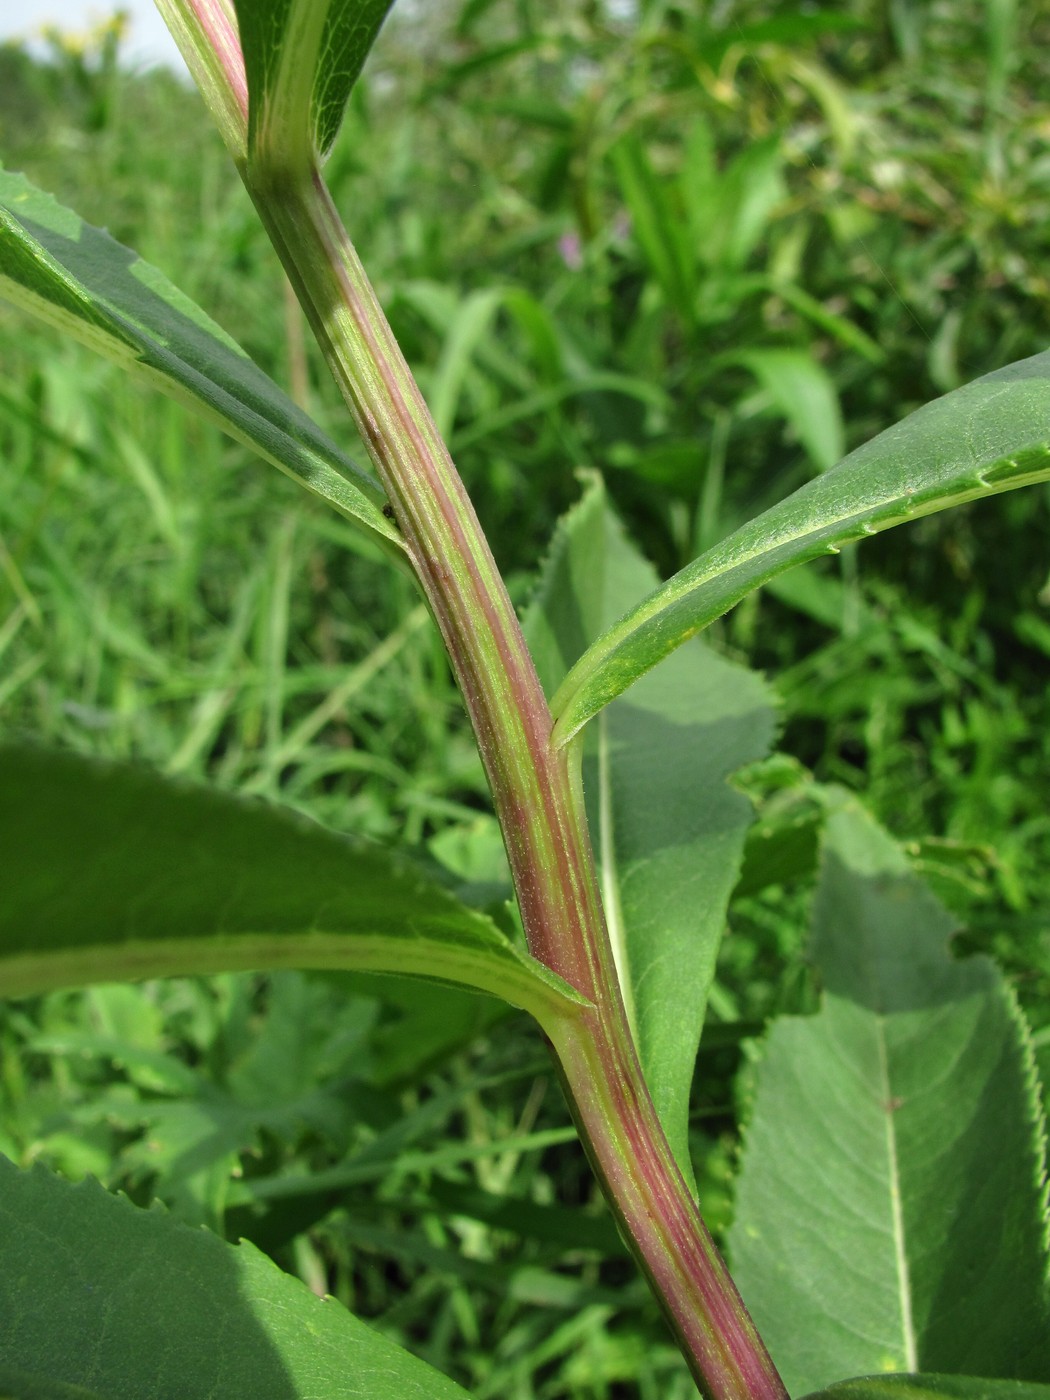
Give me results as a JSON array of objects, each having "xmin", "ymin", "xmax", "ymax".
[{"xmin": 245, "ymin": 160, "xmax": 785, "ymax": 1400}]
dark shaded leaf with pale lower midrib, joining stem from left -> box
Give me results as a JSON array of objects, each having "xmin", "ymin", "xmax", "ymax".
[{"xmin": 0, "ymin": 745, "xmax": 580, "ymax": 1023}]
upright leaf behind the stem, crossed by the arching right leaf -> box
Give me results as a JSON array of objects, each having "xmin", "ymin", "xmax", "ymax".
[{"xmin": 525, "ymin": 476, "xmax": 774, "ymax": 1180}]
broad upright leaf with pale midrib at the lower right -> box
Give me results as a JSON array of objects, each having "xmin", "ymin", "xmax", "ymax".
[{"xmin": 729, "ymin": 802, "xmax": 1050, "ymax": 1394}]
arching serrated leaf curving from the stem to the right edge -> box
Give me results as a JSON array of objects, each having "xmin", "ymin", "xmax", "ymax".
[{"xmin": 552, "ymin": 351, "xmax": 1050, "ymax": 743}]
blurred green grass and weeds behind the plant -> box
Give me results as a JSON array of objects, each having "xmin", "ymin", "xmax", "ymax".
[{"xmin": 0, "ymin": 0, "xmax": 1050, "ymax": 1400}]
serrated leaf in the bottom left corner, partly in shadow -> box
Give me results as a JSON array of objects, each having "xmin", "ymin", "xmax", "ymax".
[{"xmin": 0, "ymin": 1158, "xmax": 466, "ymax": 1400}]
